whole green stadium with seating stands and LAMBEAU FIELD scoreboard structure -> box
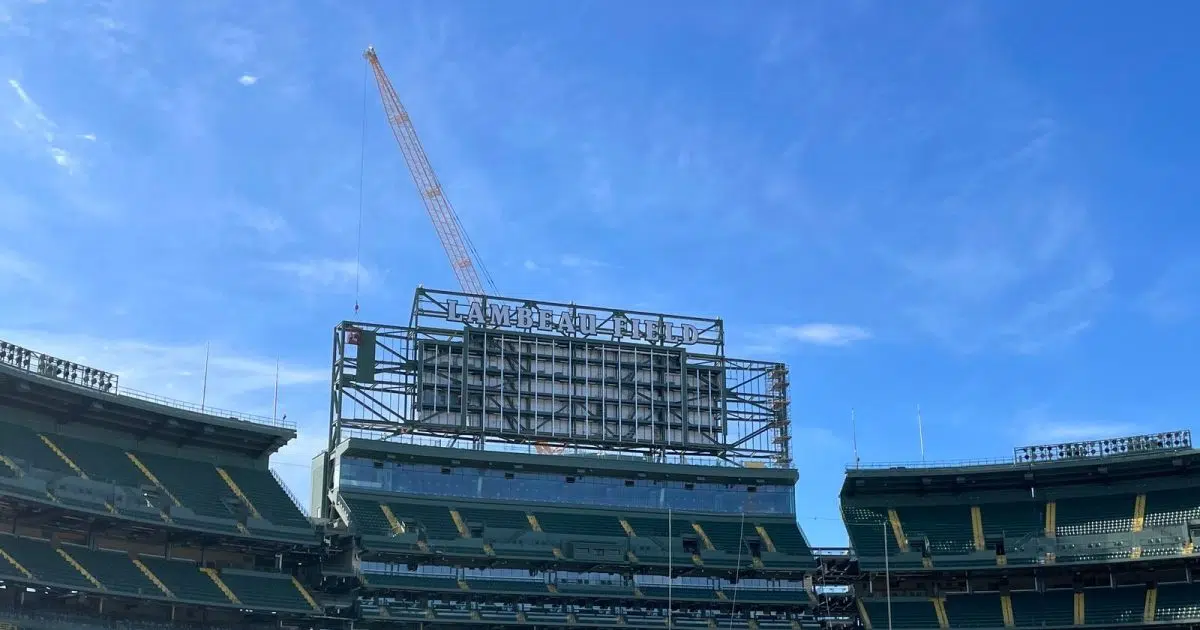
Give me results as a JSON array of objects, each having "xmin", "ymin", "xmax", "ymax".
[{"xmin": 0, "ymin": 289, "xmax": 1200, "ymax": 630}]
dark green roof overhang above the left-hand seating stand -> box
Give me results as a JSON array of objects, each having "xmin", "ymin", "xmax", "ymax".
[{"xmin": 0, "ymin": 364, "xmax": 296, "ymax": 457}]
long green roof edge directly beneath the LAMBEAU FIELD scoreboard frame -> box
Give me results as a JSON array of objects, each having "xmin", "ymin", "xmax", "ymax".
[{"xmin": 334, "ymin": 438, "xmax": 799, "ymax": 485}]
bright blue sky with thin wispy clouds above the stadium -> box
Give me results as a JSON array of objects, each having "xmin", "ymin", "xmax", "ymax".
[{"xmin": 0, "ymin": 0, "xmax": 1200, "ymax": 545}]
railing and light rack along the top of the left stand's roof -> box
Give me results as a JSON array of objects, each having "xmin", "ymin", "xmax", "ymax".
[{"xmin": 0, "ymin": 341, "xmax": 296, "ymax": 430}]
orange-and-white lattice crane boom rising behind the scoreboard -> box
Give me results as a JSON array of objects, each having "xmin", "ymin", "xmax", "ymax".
[{"xmin": 362, "ymin": 47, "xmax": 496, "ymax": 295}]
